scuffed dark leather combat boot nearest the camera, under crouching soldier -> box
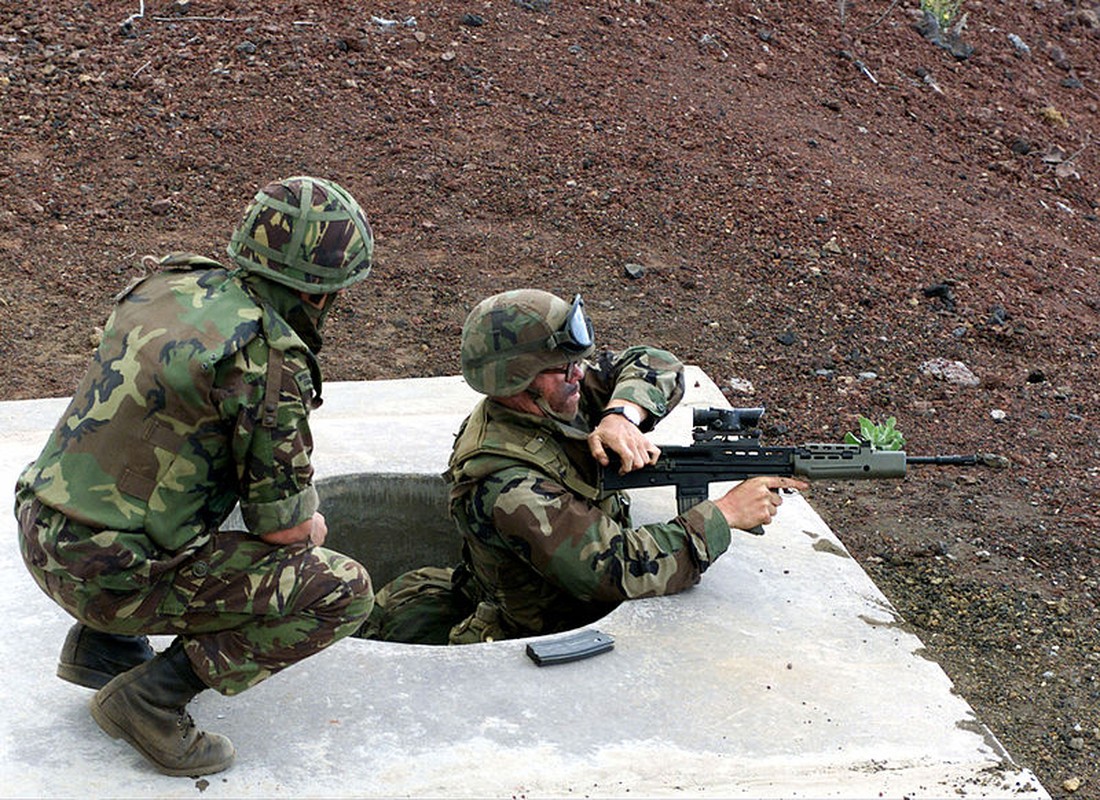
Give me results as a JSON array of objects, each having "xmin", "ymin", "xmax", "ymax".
[{"xmin": 91, "ymin": 639, "xmax": 235, "ymax": 776}]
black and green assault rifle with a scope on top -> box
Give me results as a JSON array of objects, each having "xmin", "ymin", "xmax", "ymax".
[{"xmin": 602, "ymin": 408, "xmax": 1007, "ymax": 534}]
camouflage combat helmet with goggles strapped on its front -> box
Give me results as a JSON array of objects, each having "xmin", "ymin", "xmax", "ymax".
[{"xmin": 462, "ymin": 289, "xmax": 595, "ymax": 397}]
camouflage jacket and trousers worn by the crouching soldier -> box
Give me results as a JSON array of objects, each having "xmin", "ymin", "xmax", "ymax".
[{"xmin": 15, "ymin": 256, "xmax": 373, "ymax": 694}]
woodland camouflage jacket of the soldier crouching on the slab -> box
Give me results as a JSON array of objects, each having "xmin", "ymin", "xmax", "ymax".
[{"xmin": 17, "ymin": 256, "xmax": 320, "ymax": 571}]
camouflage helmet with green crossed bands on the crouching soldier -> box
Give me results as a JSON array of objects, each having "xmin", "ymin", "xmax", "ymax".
[{"xmin": 226, "ymin": 176, "xmax": 374, "ymax": 295}]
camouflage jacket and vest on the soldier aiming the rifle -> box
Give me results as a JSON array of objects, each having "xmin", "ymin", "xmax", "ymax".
[{"xmin": 446, "ymin": 348, "xmax": 730, "ymax": 644}]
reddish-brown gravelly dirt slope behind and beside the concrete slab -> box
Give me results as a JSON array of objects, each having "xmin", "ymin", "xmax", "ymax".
[{"xmin": 0, "ymin": 0, "xmax": 1100, "ymax": 797}]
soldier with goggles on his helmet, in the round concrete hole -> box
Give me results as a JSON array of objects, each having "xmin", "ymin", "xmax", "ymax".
[{"xmin": 359, "ymin": 289, "xmax": 809, "ymax": 644}]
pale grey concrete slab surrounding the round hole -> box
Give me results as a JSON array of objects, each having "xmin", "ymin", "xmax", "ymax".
[{"xmin": 0, "ymin": 368, "xmax": 1049, "ymax": 799}]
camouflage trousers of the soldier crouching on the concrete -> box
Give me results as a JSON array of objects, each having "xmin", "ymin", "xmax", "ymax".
[{"xmin": 17, "ymin": 502, "xmax": 374, "ymax": 694}]
